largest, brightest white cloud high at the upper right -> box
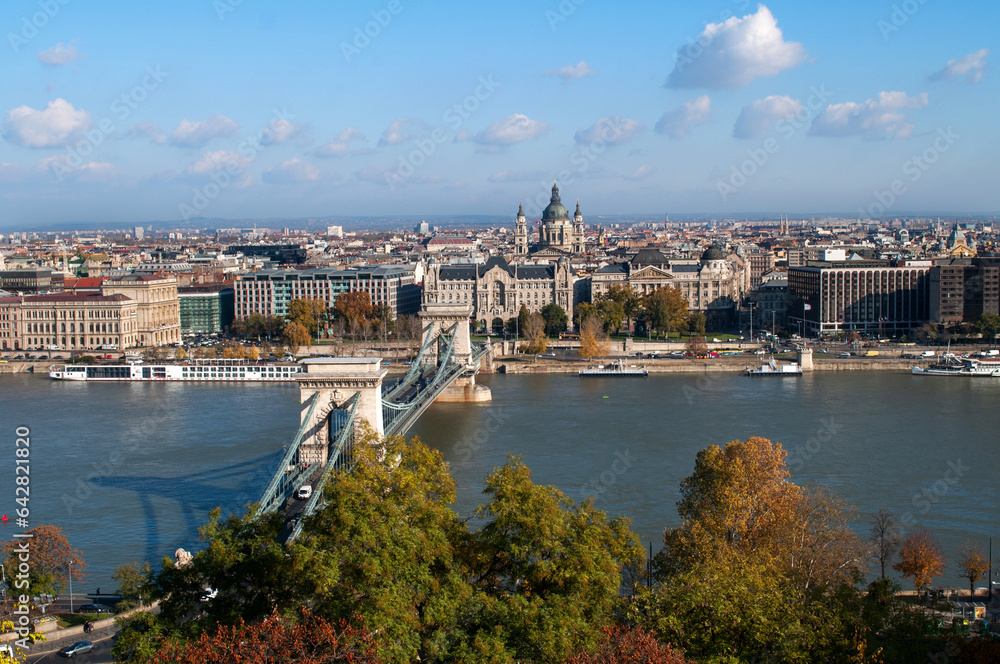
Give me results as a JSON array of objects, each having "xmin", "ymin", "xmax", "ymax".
[{"xmin": 666, "ymin": 5, "xmax": 806, "ymax": 89}]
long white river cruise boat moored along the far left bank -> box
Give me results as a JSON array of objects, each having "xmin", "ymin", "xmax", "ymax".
[{"xmin": 49, "ymin": 359, "xmax": 303, "ymax": 383}]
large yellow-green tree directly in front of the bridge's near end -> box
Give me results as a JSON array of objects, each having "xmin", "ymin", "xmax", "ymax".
[{"xmin": 293, "ymin": 429, "xmax": 471, "ymax": 662}]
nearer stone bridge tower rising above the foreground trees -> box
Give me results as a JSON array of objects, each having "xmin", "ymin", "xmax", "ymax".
[{"xmin": 296, "ymin": 357, "xmax": 387, "ymax": 464}]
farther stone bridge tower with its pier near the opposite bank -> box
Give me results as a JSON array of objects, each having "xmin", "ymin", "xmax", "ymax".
[{"xmin": 420, "ymin": 302, "xmax": 493, "ymax": 402}]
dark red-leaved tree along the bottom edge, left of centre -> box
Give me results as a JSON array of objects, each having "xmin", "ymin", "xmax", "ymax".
[{"xmin": 150, "ymin": 610, "xmax": 379, "ymax": 664}]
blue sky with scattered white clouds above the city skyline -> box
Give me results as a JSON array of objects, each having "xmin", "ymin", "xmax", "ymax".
[{"xmin": 0, "ymin": 0, "xmax": 1000, "ymax": 229}]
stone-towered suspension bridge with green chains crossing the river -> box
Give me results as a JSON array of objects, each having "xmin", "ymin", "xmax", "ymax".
[{"xmin": 258, "ymin": 303, "xmax": 490, "ymax": 541}]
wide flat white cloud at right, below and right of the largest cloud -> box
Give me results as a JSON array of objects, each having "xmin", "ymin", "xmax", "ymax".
[{"xmin": 809, "ymin": 92, "xmax": 927, "ymax": 139}]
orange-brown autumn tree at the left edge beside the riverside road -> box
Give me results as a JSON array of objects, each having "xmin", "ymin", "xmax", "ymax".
[{"xmin": 2, "ymin": 524, "xmax": 87, "ymax": 596}]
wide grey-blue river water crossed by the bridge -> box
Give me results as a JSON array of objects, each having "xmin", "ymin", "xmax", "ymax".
[{"xmin": 0, "ymin": 371, "xmax": 1000, "ymax": 590}]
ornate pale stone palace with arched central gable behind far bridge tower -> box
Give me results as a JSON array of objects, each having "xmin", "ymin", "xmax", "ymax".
[{"xmin": 424, "ymin": 256, "xmax": 573, "ymax": 328}]
